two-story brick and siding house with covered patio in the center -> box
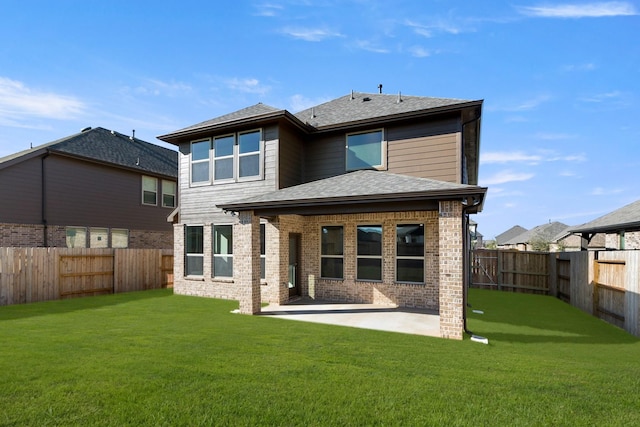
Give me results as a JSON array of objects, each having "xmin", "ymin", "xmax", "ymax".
[{"xmin": 159, "ymin": 92, "xmax": 486, "ymax": 339}]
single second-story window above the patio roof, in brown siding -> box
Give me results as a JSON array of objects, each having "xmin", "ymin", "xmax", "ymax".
[{"xmin": 346, "ymin": 129, "xmax": 387, "ymax": 171}]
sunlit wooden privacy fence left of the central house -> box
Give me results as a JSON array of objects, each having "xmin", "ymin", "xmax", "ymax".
[{"xmin": 0, "ymin": 248, "xmax": 173, "ymax": 306}]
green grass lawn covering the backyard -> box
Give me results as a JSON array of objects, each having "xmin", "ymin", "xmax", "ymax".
[{"xmin": 0, "ymin": 290, "xmax": 640, "ymax": 426}]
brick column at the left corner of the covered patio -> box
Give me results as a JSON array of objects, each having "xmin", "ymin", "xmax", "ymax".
[{"xmin": 233, "ymin": 211, "xmax": 260, "ymax": 314}]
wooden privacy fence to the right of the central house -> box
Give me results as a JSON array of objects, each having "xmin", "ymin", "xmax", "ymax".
[{"xmin": 471, "ymin": 249, "xmax": 640, "ymax": 336}]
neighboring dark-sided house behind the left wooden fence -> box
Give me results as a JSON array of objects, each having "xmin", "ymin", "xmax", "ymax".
[{"xmin": 0, "ymin": 127, "xmax": 178, "ymax": 248}]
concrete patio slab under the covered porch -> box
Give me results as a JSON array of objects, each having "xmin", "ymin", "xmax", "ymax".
[{"xmin": 260, "ymin": 298, "xmax": 440, "ymax": 337}]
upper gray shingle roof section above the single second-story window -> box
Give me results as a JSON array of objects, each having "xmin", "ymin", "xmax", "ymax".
[{"xmin": 294, "ymin": 92, "xmax": 473, "ymax": 128}]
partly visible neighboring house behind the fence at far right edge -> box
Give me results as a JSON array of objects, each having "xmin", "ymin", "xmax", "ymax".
[{"xmin": 569, "ymin": 200, "xmax": 640, "ymax": 250}]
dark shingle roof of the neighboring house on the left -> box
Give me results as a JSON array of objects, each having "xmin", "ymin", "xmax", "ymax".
[{"xmin": 0, "ymin": 127, "xmax": 178, "ymax": 178}]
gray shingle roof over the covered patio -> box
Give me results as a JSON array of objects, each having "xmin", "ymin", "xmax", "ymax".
[{"xmin": 221, "ymin": 170, "xmax": 486, "ymax": 210}]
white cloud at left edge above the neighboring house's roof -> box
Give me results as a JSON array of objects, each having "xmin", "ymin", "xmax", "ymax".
[{"xmin": 0, "ymin": 77, "xmax": 87, "ymax": 123}]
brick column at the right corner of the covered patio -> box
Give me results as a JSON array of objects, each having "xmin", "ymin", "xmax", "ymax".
[{"xmin": 438, "ymin": 201, "xmax": 464, "ymax": 340}]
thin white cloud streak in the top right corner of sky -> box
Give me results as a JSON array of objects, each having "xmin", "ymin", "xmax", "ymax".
[{"xmin": 520, "ymin": 1, "xmax": 637, "ymax": 18}]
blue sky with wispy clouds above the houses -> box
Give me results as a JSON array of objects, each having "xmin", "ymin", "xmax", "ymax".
[{"xmin": 0, "ymin": 0, "xmax": 640, "ymax": 238}]
